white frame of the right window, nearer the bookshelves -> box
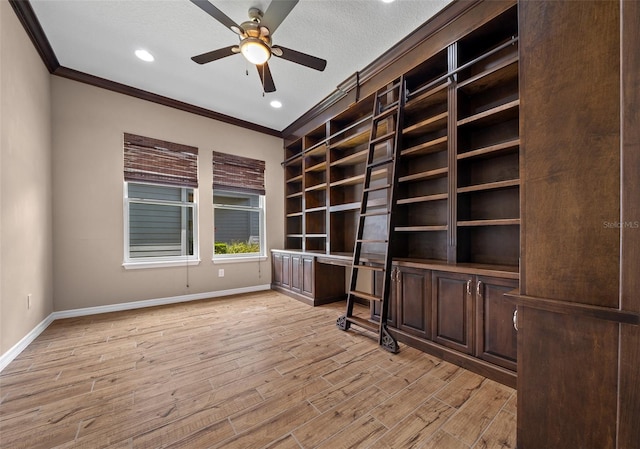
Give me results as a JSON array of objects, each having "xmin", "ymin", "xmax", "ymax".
[{"xmin": 212, "ymin": 187, "xmax": 267, "ymax": 264}]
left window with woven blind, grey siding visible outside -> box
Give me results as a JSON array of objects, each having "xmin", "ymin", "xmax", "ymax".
[{"xmin": 124, "ymin": 134, "xmax": 198, "ymax": 268}]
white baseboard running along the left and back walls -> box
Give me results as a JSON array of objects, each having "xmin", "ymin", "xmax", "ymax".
[{"xmin": 0, "ymin": 284, "xmax": 271, "ymax": 372}]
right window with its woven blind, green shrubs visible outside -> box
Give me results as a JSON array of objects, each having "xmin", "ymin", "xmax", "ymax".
[{"xmin": 213, "ymin": 152, "xmax": 266, "ymax": 259}]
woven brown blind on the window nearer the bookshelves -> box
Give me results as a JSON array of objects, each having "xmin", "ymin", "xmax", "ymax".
[{"xmin": 213, "ymin": 151, "xmax": 265, "ymax": 195}]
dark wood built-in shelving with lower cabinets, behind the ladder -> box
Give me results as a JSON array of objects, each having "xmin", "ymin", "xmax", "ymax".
[{"xmin": 274, "ymin": 1, "xmax": 520, "ymax": 386}]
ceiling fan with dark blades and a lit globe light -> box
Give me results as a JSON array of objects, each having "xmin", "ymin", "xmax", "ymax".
[{"xmin": 185, "ymin": 0, "xmax": 327, "ymax": 92}]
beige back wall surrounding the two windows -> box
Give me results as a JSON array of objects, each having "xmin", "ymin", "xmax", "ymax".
[{"xmin": 52, "ymin": 77, "xmax": 284, "ymax": 311}]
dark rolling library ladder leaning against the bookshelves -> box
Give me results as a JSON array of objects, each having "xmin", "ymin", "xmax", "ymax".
[{"xmin": 336, "ymin": 77, "xmax": 406, "ymax": 353}]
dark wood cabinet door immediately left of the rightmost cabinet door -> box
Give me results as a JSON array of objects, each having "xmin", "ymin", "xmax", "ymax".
[{"xmin": 432, "ymin": 271, "xmax": 474, "ymax": 354}]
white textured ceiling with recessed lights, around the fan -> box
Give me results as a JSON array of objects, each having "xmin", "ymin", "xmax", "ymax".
[{"xmin": 31, "ymin": 0, "xmax": 450, "ymax": 131}]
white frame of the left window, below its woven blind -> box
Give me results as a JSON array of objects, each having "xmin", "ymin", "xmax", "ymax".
[{"xmin": 122, "ymin": 181, "xmax": 200, "ymax": 269}]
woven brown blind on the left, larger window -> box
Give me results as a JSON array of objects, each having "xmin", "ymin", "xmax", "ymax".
[{"xmin": 124, "ymin": 133, "xmax": 198, "ymax": 189}]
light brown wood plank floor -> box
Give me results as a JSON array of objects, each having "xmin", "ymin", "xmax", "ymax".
[{"xmin": 0, "ymin": 292, "xmax": 516, "ymax": 449}]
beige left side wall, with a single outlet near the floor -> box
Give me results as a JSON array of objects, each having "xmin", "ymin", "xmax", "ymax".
[{"xmin": 0, "ymin": 0, "xmax": 53, "ymax": 354}]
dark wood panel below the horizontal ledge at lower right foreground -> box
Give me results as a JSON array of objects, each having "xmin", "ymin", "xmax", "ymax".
[{"xmin": 518, "ymin": 306, "xmax": 620, "ymax": 449}]
